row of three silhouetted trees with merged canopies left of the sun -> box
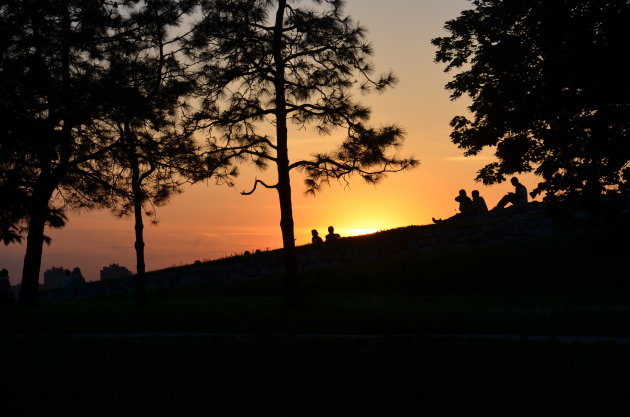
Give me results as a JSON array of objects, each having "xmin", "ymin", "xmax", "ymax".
[{"xmin": 0, "ymin": 0, "xmax": 417, "ymax": 304}]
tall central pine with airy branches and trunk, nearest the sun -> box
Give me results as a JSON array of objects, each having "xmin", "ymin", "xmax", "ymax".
[{"xmin": 189, "ymin": 0, "xmax": 416, "ymax": 304}]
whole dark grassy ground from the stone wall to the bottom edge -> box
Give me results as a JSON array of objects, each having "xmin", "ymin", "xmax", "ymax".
[{"xmin": 0, "ymin": 229, "xmax": 630, "ymax": 416}]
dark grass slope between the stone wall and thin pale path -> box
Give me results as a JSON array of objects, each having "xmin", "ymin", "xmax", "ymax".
[{"xmin": 0, "ymin": 229, "xmax": 630, "ymax": 336}]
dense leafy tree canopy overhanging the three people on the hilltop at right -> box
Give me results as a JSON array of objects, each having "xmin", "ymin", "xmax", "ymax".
[{"xmin": 432, "ymin": 0, "xmax": 630, "ymax": 199}]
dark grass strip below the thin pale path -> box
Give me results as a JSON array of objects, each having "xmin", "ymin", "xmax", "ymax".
[{"xmin": 0, "ymin": 336, "xmax": 630, "ymax": 417}]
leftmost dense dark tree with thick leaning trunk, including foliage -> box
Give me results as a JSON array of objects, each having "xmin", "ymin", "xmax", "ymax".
[{"xmin": 0, "ymin": 0, "xmax": 119, "ymax": 303}]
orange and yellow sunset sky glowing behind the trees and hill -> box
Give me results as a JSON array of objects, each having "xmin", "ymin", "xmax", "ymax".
[{"xmin": 0, "ymin": 0, "xmax": 535, "ymax": 284}]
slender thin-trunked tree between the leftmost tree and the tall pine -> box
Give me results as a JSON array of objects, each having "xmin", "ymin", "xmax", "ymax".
[{"xmin": 101, "ymin": 0, "xmax": 197, "ymax": 305}]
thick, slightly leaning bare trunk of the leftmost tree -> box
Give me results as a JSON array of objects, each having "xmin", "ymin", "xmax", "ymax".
[{"xmin": 19, "ymin": 187, "xmax": 52, "ymax": 304}]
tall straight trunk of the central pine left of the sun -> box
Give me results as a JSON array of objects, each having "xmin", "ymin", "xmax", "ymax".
[{"xmin": 273, "ymin": 0, "xmax": 301, "ymax": 306}]
